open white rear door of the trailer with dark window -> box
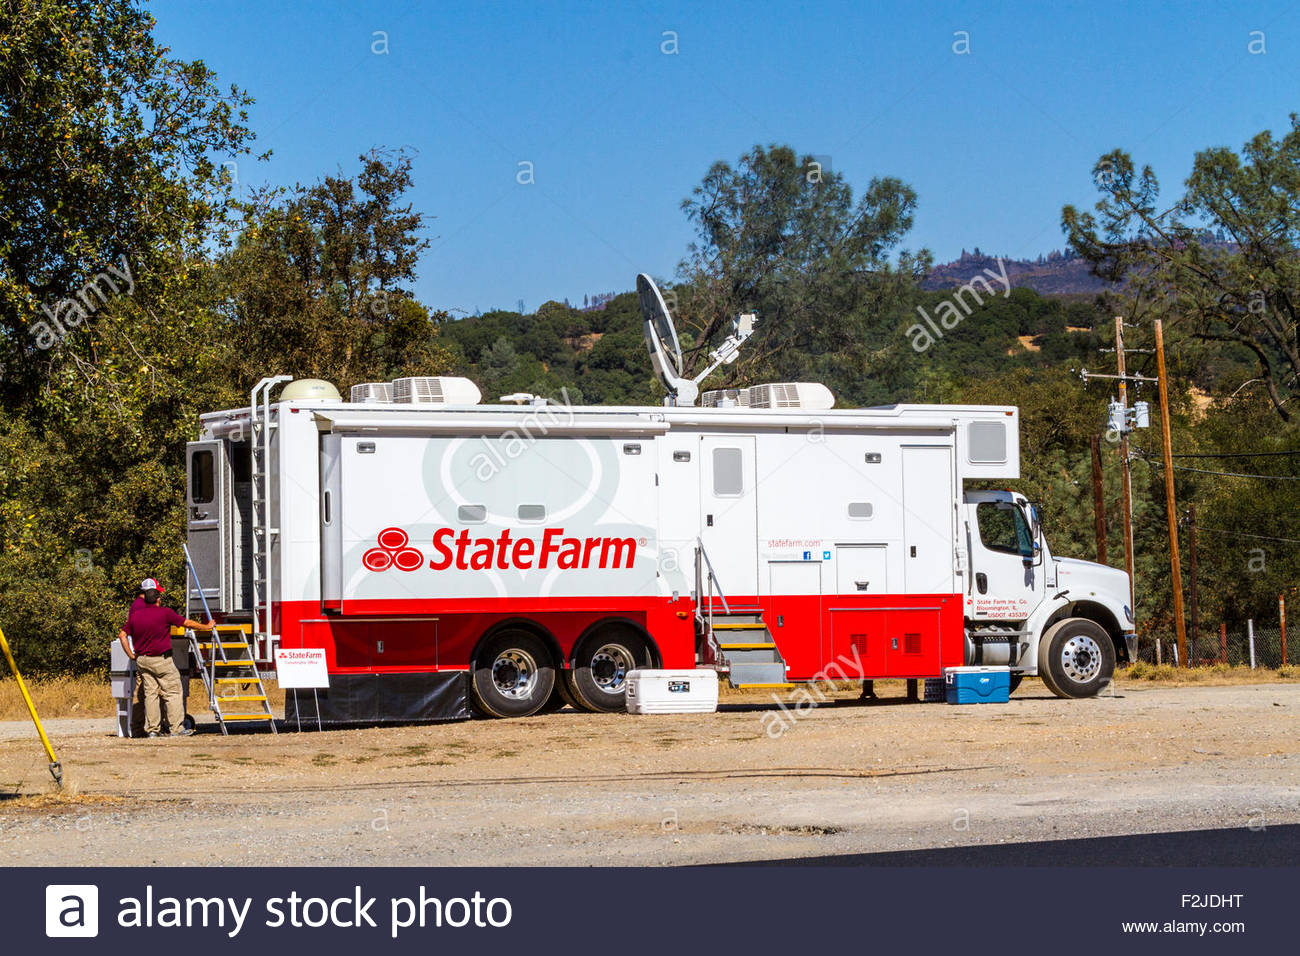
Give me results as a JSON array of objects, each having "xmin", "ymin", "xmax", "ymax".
[{"xmin": 185, "ymin": 441, "xmax": 230, "ymax": 613}]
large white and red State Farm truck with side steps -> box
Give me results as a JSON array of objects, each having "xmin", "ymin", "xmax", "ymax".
[{"xmin": 187, "ymin": 378, "xmax": 1134, "ymax": 722}]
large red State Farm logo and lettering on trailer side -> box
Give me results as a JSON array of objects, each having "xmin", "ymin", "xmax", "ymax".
[{"xmin": 361, "ymin": 528, "xmax": 646, "ymax": 571}]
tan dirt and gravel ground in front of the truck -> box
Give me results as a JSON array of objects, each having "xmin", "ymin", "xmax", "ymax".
[{"xmin": 0, "ymin": 682, "xmax": 1300, "ymax": 865}]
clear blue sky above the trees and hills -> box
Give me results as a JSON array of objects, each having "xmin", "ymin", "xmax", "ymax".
[{"xmin": 151, "ymin": 0, "xmax": 1300, "ymax": 312}]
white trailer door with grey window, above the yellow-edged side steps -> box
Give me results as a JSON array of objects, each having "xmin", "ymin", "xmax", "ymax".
[{"xmin": 699, "ymin": 434, "xmax": 758, "ymax": 600}]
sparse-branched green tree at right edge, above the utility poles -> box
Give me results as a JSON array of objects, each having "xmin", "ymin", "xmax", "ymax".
[{"xmin": 1061, "ymin": 114, "xmax": 1300, "ymax": 420}]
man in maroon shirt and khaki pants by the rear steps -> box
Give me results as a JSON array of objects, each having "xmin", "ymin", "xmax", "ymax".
[{"xmin": 117, "ymin": 578, "xmax": 212, "ymax": 737}]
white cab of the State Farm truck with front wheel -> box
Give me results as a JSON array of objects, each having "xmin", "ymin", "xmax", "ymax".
[{"xmin": 962, "ymin": 490, "xmax": 1136, "ymax": 697}]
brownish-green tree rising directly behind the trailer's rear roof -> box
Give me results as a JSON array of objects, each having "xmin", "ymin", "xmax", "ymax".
[{"xmin": 220, "ymin": 151, "xmax": 449, "ymax": 388}]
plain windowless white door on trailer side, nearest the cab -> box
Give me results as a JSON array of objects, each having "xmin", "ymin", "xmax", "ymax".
[{"xmin": 902, "ymin": 445, "xmax": 958, "ymax": 594}]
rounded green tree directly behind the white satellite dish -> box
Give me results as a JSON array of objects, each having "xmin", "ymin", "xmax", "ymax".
[{"xmin": 670, "ymin": 146, "xmax": 930, "ymax": 390}]
